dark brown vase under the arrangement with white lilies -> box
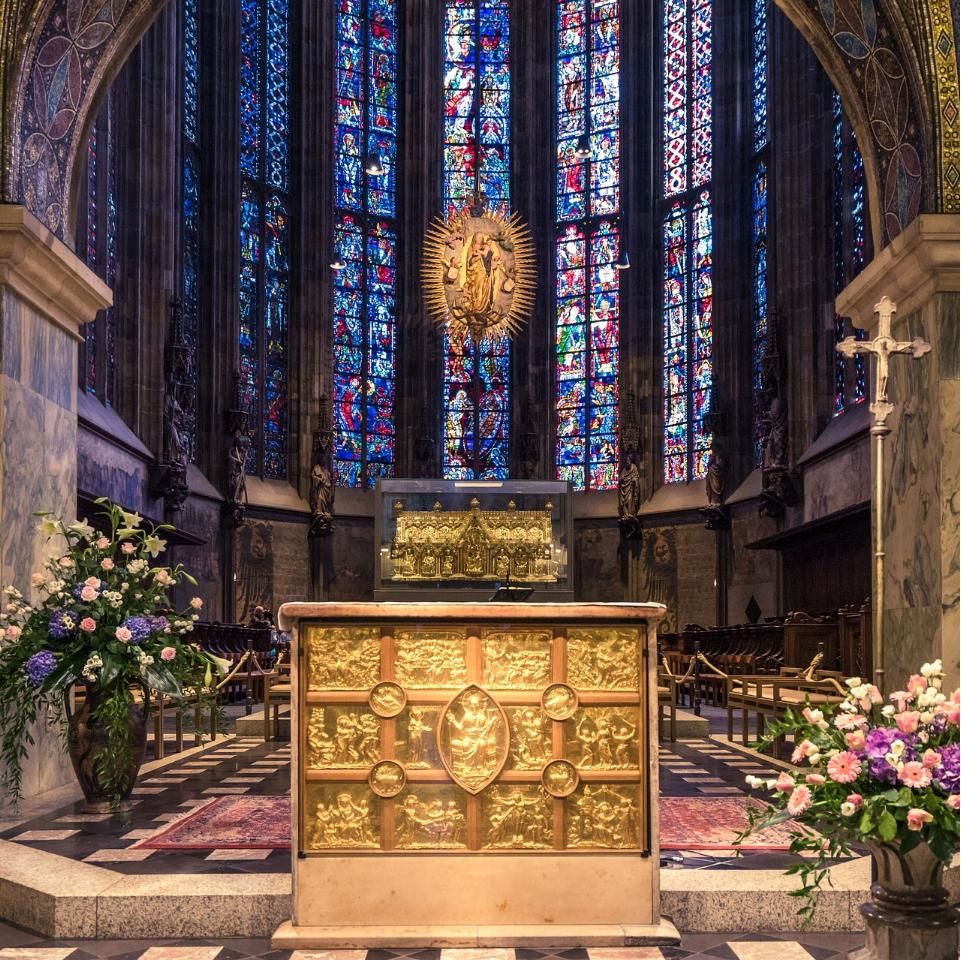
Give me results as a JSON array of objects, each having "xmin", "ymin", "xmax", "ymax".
[{"xmin": 67, "ymin": 688, "xmax": 147, "ymax": 813}]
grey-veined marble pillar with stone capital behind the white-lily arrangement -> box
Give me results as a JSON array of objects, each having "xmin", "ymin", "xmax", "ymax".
[{"xmin": 0, "ymin": 204, "xmax": 112, "ymax": 796}]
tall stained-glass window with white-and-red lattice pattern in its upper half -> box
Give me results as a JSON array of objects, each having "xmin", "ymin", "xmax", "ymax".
[{"xmin": 661, "ymin": 0, "xmax": 714, "ymax": 483}]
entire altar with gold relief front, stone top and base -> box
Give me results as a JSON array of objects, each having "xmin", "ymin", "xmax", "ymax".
[{"xmin": 274, "ymin": 603, "xmax": 676, "ymax": 947}]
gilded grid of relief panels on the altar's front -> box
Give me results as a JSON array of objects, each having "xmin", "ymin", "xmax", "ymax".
[{"xmin": 301, "ymin": 624, "xmax": 647, "ymax": 853}]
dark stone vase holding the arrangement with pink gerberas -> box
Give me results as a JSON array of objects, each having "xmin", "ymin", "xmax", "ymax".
[{"xmin": 850, "ymin": 842, "xmax": 958, "ymax": 960}]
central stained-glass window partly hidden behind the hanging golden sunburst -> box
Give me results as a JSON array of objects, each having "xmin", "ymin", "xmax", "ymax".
[{"xmin": 442, "ymin": 0, "xmax": 511, "ymax": 480}]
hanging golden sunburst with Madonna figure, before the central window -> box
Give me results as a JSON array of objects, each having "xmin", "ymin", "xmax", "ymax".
[{"xmin": 422, "ymin": 206, "xmax": 535, "ymax": 343}]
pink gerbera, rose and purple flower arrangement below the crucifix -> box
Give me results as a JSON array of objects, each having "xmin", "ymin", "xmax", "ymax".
[{"xmin": 738, "ymin": 660, "xmax": 961, "ymax": 920}]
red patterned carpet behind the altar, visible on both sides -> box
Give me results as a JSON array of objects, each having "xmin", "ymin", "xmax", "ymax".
[{"xmin": 134, "ymin": 797, "xmax": 792, "ymax": 850}]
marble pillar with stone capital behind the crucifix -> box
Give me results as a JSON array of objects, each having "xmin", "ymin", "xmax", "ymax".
[{"xmin": 837, "ymin": 214, "xmax": 959, "ymax": 689}]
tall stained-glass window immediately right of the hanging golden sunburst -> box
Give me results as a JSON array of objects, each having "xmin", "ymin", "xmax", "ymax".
[{"xmin": 554, "ymin": 0, "xmax": 621, "ymax": 490}]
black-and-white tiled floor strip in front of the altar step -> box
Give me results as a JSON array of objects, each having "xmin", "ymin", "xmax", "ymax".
[{"xmin": 0, "ymin": 923, "xmax": 863, "ymax": 960}]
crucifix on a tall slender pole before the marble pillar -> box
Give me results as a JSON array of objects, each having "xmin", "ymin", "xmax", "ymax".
[{"xmin": 837, "ymin": 297, "xmax": 931, "ymax": 690}]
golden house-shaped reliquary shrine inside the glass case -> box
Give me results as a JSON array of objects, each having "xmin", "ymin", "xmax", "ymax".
[{"xmin": 391, "ymin": 497, "xmax": 557, "ymax": 583}]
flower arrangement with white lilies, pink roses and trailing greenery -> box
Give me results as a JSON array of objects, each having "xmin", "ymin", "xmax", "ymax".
[{"xmin": 0, "ymin": 499, "xmax": 220, "ymax": 806}]
